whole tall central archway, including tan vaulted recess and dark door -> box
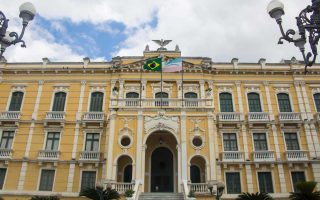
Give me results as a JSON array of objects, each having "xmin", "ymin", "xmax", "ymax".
[{"xmin": 144, "ymin": 131, "xmax": 178, "ymax": 192}]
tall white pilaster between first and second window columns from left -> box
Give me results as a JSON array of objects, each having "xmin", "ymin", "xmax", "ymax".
[{"xmin": 17, "ymin": 80, "xmax": 44, "ymax": 191}]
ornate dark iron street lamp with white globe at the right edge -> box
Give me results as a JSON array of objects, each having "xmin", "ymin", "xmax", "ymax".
[{"xmin": 267, "ymin": 0, "xmax": 320, "ymax": 73}]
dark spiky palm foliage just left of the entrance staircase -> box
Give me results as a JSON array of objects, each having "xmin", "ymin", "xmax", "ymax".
[{"xmin": 79, "ymin": 187, "xmax": 120, "ymax": 200}]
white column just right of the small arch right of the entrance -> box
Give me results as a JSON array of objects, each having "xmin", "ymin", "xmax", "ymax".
[{"xmin": 206, "ymin": 112, "xmax": 218, "ymax": 180}]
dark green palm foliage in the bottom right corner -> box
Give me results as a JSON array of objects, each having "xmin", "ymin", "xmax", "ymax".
[{"xmin": 289, "ymin": 181, "xmax": 320, "ymax": 200}]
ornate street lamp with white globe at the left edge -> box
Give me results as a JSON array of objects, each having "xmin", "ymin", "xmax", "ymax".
[{"xmin": 0, "ymin": 2, "xmax": 36, "ymax": 60}]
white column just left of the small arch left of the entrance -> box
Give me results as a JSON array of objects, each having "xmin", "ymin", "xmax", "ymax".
[{"xmin": 106, "ymin": 110, "xmax": 116, "ymax": 181}]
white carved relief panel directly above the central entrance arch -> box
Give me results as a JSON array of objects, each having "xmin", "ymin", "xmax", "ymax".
[{"xmin": 144, "ymin": 111, "xmax": 179, "ymax": 134}]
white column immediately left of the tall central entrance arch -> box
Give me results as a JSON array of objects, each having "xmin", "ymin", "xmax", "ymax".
[{"xmin": 136, "ymin": 110, "xmax": 144, "ymax": 179}]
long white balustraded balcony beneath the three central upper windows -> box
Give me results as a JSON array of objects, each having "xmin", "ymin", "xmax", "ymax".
[{"xmin": 110, "ymin": 99, "xmax": 213, "ymax": 109}]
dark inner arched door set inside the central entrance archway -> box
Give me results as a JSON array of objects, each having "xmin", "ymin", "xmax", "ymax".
[{"xmin": 151, "ymin": 147, "xmax": 174, "ymax": 192}]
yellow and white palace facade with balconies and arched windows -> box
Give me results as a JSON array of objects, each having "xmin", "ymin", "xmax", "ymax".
[{"xmin": 0, "ymin": 45, "xmax": 320, "ymax": 199}]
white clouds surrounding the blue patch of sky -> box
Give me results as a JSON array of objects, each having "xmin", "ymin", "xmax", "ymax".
[{"xmin": 1, "ymin": 0, "xmax": 316, "ymax": 62}]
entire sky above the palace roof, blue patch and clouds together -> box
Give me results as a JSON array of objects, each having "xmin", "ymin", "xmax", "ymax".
[{"xmin": 0, "ymin": 0, "xmax": 310, "ymax": 62}]
